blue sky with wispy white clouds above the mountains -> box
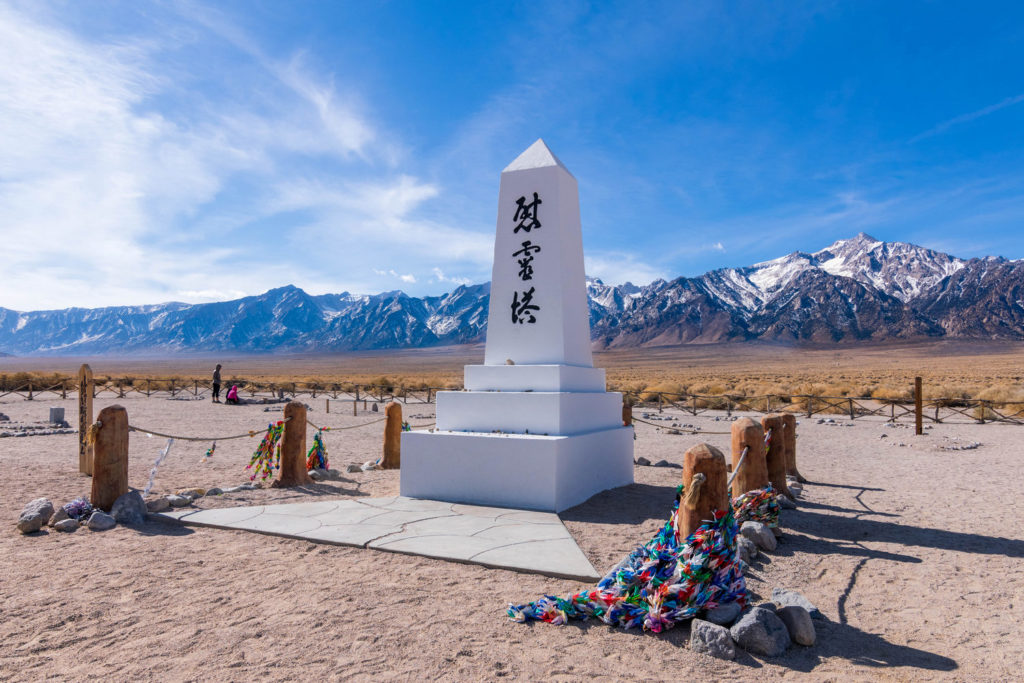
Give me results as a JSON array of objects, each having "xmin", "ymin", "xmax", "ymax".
[{"xmin": 0, "ymin": 0, "xmax": 1024, "ymax": 310}]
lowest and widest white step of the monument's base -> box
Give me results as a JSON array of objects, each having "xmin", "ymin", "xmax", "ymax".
[{"xmin": 401, "ymin": 427, "xmax": 633, "ymax": 512}]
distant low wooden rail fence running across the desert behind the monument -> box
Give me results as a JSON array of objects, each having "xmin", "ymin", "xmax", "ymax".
[{"xmin": 0, "ymin": 378, "xmax": 1024, "ymax": 424}]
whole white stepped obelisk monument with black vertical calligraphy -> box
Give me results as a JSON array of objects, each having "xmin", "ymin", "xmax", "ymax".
[{"xmin": 401, "ymin": 140, "xmax": 633, "ymax": 512}]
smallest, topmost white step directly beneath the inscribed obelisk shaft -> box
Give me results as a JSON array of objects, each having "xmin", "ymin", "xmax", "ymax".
[{"xmin": 464, "ymin": 366, "xmax": 605, "ymax": 392}]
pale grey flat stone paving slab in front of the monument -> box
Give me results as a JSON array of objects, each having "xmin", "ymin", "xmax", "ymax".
[{"xmin": 161, "ymin": 497, "xmax": 600, "ymax": 582}]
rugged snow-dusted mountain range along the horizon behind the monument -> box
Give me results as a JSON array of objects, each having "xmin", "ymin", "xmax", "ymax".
[{"xmin": 0, "ymin": 232, "xmax": 1024, "ymax": 355}]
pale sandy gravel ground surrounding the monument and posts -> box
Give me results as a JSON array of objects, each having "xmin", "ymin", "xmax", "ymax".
[{"xmin": 0, "ymin": 397, "xmax": 1024, "ymax": 681}]
